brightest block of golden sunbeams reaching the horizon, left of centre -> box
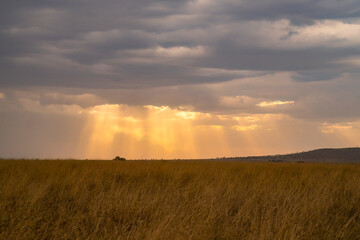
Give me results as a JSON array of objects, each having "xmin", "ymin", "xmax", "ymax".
[{"xmin": 84, "ymin": 105, "xmax": 202, "ymax": 158}]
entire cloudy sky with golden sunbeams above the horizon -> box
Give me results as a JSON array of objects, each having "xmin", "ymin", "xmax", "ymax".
[{"xmin": 0, "ymin": 0, "xmax": 360, "ymax": 159}]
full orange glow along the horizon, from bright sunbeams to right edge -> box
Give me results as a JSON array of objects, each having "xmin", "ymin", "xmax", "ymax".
[{"xmin": 81, "ymin": 104, "xmax": 360, "ymax": 159}]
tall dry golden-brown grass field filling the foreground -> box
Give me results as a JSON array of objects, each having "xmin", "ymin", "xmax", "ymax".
[{"xmin": 0, "ymin": 161, "xmax": 360, "ymax": 240}]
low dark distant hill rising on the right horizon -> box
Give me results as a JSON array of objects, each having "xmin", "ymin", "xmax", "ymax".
[{"xmin": 222, "ymin": 148, "xmax": 360, "ymax": 163}]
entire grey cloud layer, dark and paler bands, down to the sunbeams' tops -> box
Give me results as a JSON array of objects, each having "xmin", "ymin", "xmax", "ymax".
[{"xmin": 0, "ymin": 0, "xmax": 360, "ymax": 126}]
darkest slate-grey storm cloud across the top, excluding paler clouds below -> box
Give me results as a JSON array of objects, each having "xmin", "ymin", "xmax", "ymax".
[{"xmin": 0, "ymin": 0, "xmax": 360, "ymax": 88}]
